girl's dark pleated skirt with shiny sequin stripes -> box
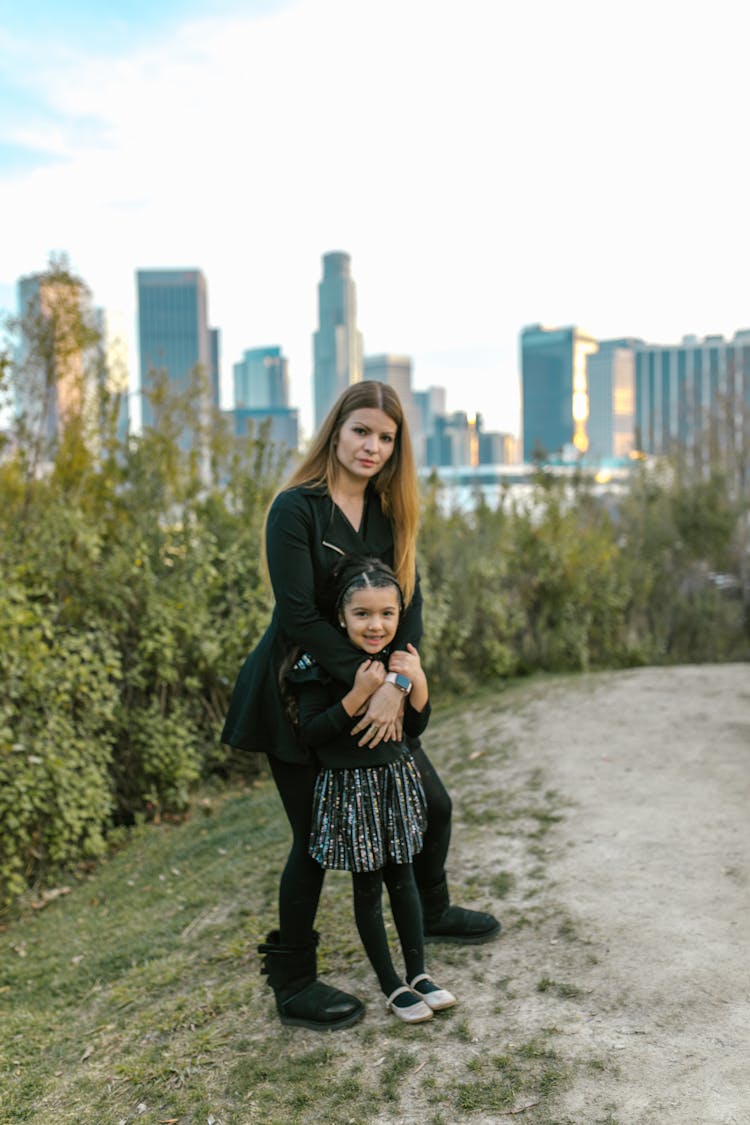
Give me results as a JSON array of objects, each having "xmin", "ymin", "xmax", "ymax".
[{"xmin": 309, "ymin": 753, "xmax": 427, "ymax": 871}]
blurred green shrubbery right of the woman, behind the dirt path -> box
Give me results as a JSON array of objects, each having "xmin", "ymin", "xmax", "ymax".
[{"xmin": 421, "ymin": 466, "xmax": 750, "ymax": 690}]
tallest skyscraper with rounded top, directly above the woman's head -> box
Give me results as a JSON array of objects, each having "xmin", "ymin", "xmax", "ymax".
[{"xmin": 313, "ymin": 251, "xmax": 362, "ymax": 429}]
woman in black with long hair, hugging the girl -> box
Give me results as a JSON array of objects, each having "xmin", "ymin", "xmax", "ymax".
[{"xmin": 222, "ymin": 381, "xmax": 500, "ymax": 1029}]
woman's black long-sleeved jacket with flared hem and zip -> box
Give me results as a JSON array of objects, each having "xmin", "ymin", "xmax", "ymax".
[{"xmin": 222, "ymin": 486, "xmax": 422, "ymax": 763}]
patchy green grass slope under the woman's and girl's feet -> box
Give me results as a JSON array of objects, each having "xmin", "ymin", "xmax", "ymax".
[{"xmin": 0, "ymin": 679, "xmax": 614, "ymax": 1125}]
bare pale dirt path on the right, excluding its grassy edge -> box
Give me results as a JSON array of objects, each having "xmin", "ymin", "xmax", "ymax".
[{"xmin": 470, "ymin": 665, "xmax": 750, "ymax": 1125}]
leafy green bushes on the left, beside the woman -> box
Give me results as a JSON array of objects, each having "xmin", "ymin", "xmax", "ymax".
[{"xmin": 0, "ymin": 425, "xmax": 284, "ymax": 903}]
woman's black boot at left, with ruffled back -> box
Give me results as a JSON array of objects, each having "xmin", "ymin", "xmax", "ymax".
[{"xmin": 257, "ymin": 929, "xmax": 364, "ymax": 1032}]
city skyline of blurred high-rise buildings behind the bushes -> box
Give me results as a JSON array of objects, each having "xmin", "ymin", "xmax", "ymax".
[{"xmin": 10, "ymin": 252, "xmax": 750, "ymax": 471}]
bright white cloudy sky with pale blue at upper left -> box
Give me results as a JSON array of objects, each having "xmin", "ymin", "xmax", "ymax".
[{"xmin": 0, "ymin": 0, "xmax": 750, "ymax": 433}]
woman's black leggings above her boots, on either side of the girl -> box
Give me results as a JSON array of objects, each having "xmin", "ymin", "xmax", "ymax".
[{"xmin": 269, "ymin": 740, "xmax": 451, "ymax": 949}]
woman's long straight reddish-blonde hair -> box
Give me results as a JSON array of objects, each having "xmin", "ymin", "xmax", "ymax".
[{"xmin": 264, "ymin": 380, "xmax": 419, "ymax": 605}]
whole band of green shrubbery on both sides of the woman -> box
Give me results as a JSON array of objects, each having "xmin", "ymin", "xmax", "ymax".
[{"xmin": 0, "ymin": 258, "xmax": 749, "ymax": 909}]
